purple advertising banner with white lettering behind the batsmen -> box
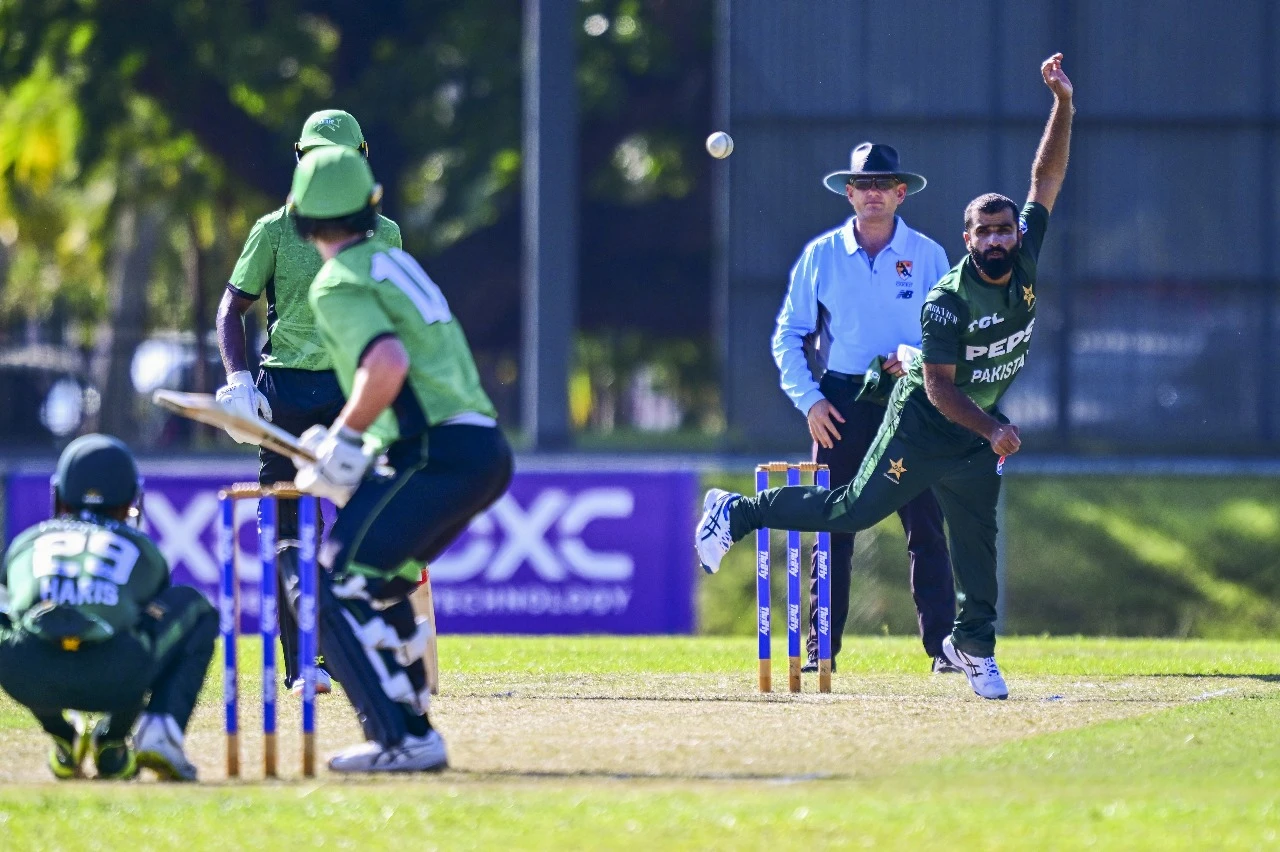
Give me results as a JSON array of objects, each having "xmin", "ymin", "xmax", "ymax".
[{"xmin": 6, "ymin": 471, "xmax": 698, "ymax": 633}]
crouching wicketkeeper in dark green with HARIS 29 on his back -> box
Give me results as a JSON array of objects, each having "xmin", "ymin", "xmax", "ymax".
[{"xmin": 0, "ymin": 435, "xmax": 218, "ymax": 780}]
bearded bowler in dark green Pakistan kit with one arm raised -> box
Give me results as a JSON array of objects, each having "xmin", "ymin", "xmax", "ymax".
[{"xmin": 695, "ymin": 54, "xmax": 1075, "ymax": 698}]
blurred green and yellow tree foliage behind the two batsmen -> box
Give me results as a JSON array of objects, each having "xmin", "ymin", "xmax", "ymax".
[{"xmin": 0, "ymin": 0, "xmax": 710, "ymax": 434}]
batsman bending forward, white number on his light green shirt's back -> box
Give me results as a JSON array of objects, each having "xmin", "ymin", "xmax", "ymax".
[{"xmin": 289, "ymin": 146, "xmax": 512, "ymax": 771}]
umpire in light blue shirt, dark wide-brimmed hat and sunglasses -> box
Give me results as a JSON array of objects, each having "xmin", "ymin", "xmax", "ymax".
[{"xmin": 773, "ymin": 142, "xmax": 959, "ymax": 672}]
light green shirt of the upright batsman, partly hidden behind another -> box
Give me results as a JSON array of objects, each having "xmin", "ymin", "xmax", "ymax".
[{"xmin": 227, "ymin": 207, "xmax": 401, "ymax": 370}]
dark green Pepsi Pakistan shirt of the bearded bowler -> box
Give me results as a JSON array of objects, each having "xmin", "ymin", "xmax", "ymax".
[{"xmin": 895, "ymin": 202, "xmax": 1048, "ymax": 417}]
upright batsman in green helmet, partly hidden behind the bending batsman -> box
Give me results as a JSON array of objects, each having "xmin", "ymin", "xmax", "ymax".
[{"xmin": 218, "ymin": 110, "xmax": 402, "ymax": 692}]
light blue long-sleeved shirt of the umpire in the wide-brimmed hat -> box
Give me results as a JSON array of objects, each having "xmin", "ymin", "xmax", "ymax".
[{"xmin": 773, "ymin": 216, "xmax": 950, "ymax": 414}]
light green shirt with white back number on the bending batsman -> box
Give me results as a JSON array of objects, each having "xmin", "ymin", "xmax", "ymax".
[{"xmin": 311, "ymin": 238, "xmax": 497, "ymax": 446}]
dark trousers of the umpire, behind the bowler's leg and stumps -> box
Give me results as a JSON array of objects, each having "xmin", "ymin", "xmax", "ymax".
[{"xmin": 808, "ymin": 374, "xmax": 956, "ymax": 660}]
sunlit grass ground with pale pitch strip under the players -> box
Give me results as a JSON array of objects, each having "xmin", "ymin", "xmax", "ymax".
[{"xmin": 0, "ymin": 637, "xmax": 1280, "ymax": 849}]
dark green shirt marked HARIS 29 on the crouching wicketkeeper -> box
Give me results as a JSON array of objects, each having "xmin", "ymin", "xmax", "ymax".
[{"xmin": 0, "ymin": 517, "xmax": 169, "ymax": 639}]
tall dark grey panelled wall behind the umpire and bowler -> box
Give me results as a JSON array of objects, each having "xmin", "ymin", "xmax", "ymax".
[{"xmin": 717, "ymin": 0, "xmax": 1280, "ymax": 453}]
